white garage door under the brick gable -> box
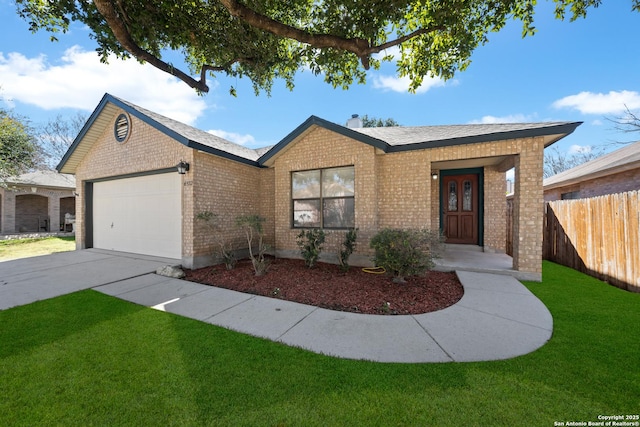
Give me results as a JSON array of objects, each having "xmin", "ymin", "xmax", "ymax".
[{"xmin": 93, "ymin": 173, "xmax": 182, "ymax": 259}]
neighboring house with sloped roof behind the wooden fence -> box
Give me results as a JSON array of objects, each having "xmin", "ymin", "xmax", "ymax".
[{"xmin": 544, "ymin": 141, "xmax": 640, "ymax": 202}]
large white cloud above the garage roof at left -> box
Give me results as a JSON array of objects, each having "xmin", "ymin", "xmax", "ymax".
[{"xmin": 0, "ymin": 46, "xmax": 207, "ymax": 124}]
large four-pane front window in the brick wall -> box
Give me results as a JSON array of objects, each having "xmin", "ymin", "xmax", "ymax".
[{"xmin": 291, "ymin": 166, "xmax": 355, "ymax": 228}]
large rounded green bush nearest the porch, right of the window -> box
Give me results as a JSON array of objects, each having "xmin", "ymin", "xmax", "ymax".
[{"xmin": 370, "ymin": 228, "xmax": 443, "ymax": 283}]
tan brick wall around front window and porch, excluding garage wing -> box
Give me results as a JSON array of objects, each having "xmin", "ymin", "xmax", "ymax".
[{"xmin": 273, "ymin": 128, "xmax": 543, "ymax": 279}]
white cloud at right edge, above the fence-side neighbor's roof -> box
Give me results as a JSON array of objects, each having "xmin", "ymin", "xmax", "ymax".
[{"xmin": 552, "ymin": 90, "xmax": 640, "ymax": 114}]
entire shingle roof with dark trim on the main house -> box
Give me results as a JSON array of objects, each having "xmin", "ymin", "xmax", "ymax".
[{"xmin": 57, "ymin": 94, "xmax": 580, "ymax": 173}]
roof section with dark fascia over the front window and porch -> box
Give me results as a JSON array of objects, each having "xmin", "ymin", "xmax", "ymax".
[{"xmin": 259, "ymin": 116, "xmax": 582, "ymax": 164}]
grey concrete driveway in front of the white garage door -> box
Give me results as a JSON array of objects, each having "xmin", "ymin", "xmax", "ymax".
[{"xmin": 0, "ymin": 249, "xmax": 180, "ymax": 310}]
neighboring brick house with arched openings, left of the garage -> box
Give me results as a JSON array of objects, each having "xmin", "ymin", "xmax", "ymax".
[{"xmin": 0, "ymin": 171, "xmax": 76, "ymax": 234}]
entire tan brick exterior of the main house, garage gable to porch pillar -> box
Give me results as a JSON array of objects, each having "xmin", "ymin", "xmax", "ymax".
[{"xmin": 76, "ymin": 112, "xmax": 544, "ymax": 280}]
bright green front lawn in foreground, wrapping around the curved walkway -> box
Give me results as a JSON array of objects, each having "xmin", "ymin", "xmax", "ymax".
[{"xmin": 0, "ymin": 263, "xmax": 640, "ymax": 426}]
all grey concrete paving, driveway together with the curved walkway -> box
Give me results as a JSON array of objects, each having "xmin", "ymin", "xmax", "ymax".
[{"xmin": 0, "ymin": 250, "xmax": 553, "ymax": 363}]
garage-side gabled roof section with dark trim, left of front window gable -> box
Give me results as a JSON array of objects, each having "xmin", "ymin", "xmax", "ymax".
[{"xmin": 56, "ymin": 93, "xmax": 262, "ymax": 173}]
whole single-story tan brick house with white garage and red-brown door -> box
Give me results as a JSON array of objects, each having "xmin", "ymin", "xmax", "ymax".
[{"xmin": 58, "ymin": 94, "xmax": 580, "ymax": 280}]
